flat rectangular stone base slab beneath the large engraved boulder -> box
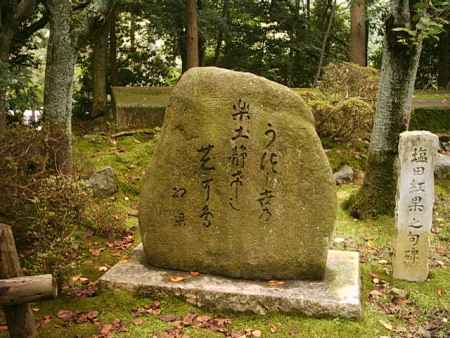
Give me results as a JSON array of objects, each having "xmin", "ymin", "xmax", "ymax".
[{"xmin": 100, "ymin": 245, "xmax": 362, "ymax": 319}]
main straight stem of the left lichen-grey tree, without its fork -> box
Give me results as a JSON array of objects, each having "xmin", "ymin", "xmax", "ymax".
[{"xmin": 44, "ymin": 0, "xmax": 76, "ymax": 174}]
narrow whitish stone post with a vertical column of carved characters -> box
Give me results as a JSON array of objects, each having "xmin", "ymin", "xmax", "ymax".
[{"xmin": 392, "ymin": 131, "xmax": 439, "ymax": 282}]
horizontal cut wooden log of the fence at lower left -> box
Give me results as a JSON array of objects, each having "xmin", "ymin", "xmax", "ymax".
[{"xmin": 0, "ymin": 275, "xmax": 58, "ymax": 305}]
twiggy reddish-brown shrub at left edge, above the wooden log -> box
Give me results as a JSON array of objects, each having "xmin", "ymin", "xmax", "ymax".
[{"xmin": 0, "ymin": 125, "xmax": 122, "ymax": 283}]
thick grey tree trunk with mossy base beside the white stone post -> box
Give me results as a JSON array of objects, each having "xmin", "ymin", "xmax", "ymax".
[{"xmin": 352, "ymin": 0, "xmax": 422, "ymax": 218}]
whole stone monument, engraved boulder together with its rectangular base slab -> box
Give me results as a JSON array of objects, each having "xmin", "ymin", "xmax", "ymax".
[{"xmin": 101, "ymin": 68, "xmax": 361, "ymax": 318}]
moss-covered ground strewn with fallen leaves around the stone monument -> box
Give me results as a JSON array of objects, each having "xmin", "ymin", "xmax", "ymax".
[{"xmin": 0, "ymin": 133, "xmax": 450, "ymax": 338}]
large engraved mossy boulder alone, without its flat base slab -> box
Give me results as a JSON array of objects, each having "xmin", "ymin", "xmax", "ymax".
[{"xmin": 139, "ymin": 67, "xmax": 336, "ymax": 280}]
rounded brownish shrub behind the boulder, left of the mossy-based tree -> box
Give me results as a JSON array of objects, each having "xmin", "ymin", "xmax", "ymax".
[{"xmin": 319, "ymin": 62, "xmax": 380, "ymax": 106}]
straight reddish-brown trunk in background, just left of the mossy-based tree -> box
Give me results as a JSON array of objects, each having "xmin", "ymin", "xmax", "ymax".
[{"xmin": 350, "ymin": 0, "xmax": 367, "ymax": 66}]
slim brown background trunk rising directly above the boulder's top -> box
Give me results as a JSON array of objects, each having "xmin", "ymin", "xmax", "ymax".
[{"xmin": 186, "ymin": 0, "xmax": 199, "ymax": 69}]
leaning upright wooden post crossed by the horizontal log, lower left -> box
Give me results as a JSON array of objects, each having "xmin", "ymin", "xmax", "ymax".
[{"xmin": 0, "ymin": 224, "xmax": 38, "ymax": 338}]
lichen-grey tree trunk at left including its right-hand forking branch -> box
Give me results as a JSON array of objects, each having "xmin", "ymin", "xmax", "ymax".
[{"xmin": 44, "ymin": 0, "xmax": 114, "ymax": 174}]
